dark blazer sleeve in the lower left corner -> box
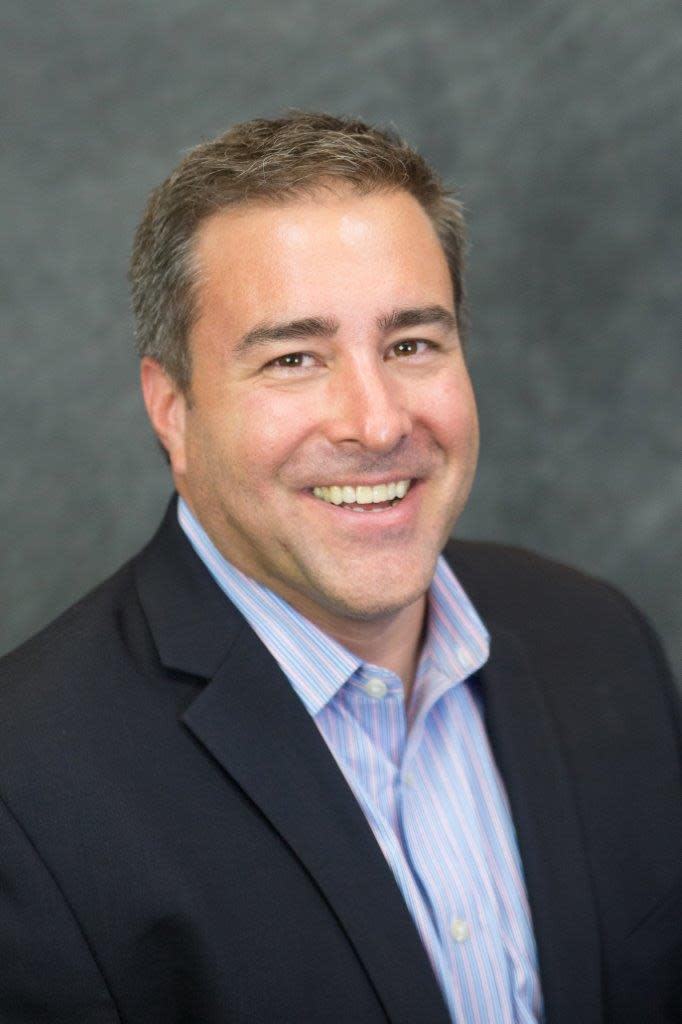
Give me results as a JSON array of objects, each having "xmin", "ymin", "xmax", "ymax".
[{"xmin": 0, "ymin": 800, "xmax": 122, "ymax": 1024}]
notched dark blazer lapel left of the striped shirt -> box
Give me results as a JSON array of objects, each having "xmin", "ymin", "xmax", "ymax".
[{"xmin": 137, "ymin": 503, "xmax": 450, "ymax": 1024}]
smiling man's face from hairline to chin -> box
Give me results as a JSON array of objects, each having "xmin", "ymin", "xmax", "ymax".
[{"xmin": 171, "ymin": 190, "xmax": 478, "ymax": 629}]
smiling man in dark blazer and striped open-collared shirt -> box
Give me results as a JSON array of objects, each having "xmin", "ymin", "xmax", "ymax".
[{"xmin": 0, "ymin": 114, "xmax": 682, "ymax": 1024}]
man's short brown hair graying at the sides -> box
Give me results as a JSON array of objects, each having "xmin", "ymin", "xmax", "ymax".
[{"xmin": 129, "ymin": 112, "xmax": 465, "ymax": 392}]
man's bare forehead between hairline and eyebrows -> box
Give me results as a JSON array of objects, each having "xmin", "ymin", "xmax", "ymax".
[{"xmin": 189, "ymin": 190, "xmax": 453, "ymax": 348}]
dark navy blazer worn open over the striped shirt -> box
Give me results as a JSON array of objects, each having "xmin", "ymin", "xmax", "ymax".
[{"xmin": 0, "ymin": 502, "xmax": 682, "ymax": 1024}]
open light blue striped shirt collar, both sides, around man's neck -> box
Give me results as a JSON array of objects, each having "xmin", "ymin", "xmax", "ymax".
[{"xmin": 177, "ymin": 498, "xmax": 483, "ymax": 716}]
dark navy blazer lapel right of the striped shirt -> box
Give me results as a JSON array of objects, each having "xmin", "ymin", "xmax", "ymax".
[{"xmin": 480, "ymin": 623, "xmax": 602, "ymax": 1024}]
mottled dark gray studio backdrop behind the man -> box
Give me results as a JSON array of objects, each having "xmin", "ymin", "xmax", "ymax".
[{"xmin": 0, "ymin": 0, "xmax": 682, "ymax": 679}]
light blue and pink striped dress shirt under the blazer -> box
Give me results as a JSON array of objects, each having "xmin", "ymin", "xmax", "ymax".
[{"xmin": 178, "ymin": 491, "xmax": 543, "ymax": 1024}]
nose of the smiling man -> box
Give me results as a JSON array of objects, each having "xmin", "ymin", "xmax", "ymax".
[{"xmin": 327, "ymin": 359, "xmax": 412, "ymax": 453}]
